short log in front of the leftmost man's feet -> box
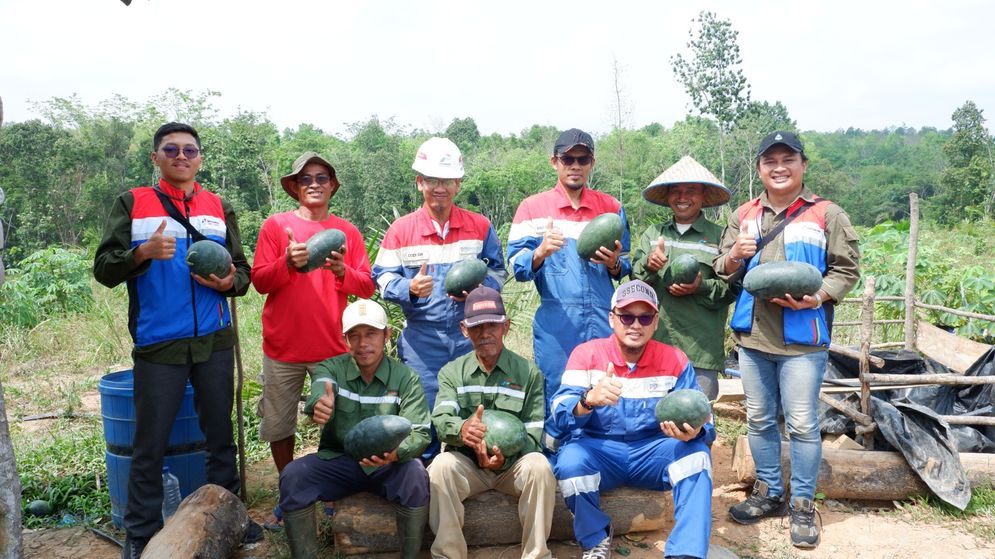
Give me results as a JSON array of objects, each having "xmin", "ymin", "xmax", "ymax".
[{"xmin": 142, "ymin": 484, "xmax": 249, "ymax": 559}]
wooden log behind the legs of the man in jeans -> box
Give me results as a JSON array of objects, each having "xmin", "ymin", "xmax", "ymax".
[{"xmin": 732, "ymin": 435, "xmax": 995, "ymax": 501}]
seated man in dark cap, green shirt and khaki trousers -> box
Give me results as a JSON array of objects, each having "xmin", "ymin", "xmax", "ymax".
[{"xmin": 428, "ymin": 286, "xmax": 556, "ymax": 559}]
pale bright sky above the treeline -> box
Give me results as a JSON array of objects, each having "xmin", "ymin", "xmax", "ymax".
[{"xmin": 0, "ymin": 0, "xmax": 995, "ymax": 135}]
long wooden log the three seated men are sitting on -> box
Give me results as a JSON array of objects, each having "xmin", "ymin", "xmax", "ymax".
[{"xmin": 332, "ymin": 487, "xmax": 674, "ymax": 555}]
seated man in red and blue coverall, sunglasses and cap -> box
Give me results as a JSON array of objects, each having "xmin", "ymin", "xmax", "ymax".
[{"xmin": 552, "ymin": 280, "xmax": 715, "ymax": 559}]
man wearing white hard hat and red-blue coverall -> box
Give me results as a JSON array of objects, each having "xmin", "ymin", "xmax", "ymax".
[{"xmin": 373, "ymin": 138, "xmax": 508, "ymax": 420}]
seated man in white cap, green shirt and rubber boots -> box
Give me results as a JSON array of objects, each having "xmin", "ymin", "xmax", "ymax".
[{"xmin": 280, "ymin": 299, "xmax": 430, "ymax": 559}]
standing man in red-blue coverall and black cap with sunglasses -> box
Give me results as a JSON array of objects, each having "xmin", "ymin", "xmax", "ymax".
[{"xmin": 508, "ymin": 128, "xmax": 632, "ymax": 452}]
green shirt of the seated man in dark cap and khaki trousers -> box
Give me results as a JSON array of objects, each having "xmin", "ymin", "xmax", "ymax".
[{"xmin": 432, "ymin": 348, "xmax": 546, "ymax": 471}]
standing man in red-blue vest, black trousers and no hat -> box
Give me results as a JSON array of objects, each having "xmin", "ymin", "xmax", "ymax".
[{"xmin": 93, "ymin": 122, "xmax": 263, "ymax": 558}]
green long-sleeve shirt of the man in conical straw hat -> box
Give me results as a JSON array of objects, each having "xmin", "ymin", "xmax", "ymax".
[{"xmin": 632, "ymin": 214, "xmax": 736, "ymax": 371}]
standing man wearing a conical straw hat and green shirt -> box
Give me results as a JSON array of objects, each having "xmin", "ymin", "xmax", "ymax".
[{"xmin": 632, "ymin": 156, "xmax": 735, "ymax": 400}]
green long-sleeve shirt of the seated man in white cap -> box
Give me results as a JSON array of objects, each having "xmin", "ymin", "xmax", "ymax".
[{"xmin": 304, "ymin": 353, "xmax": 432, "ymax": 462}]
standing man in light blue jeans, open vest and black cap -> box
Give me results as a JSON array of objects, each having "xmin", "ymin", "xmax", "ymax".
[{"xmin": 713, "ymin": 131, "xmax": 860, "ymax": 548}]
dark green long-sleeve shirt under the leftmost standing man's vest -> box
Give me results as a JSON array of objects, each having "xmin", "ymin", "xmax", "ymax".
[{"xmin": 93, "ymin": 191, "xmax": 251, "ymax": 365}]
